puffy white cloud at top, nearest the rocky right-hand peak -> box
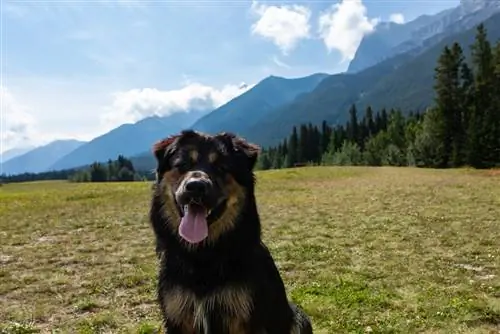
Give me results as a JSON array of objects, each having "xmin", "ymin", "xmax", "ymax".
[{"xmin": 319, "ymin": 0, "xmax": 379, "ymax": 62}]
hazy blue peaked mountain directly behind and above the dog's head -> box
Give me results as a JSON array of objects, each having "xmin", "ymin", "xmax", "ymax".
[{"xmin": 192, "ymin": 73, "xmax": 328, "ymax": 133}]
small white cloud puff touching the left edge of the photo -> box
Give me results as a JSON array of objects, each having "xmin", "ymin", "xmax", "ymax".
[{"xmin": 0, "ymin": 87, "xmax": 36, "ymax": 152}]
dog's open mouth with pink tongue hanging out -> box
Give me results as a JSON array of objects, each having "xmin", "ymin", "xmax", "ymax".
[{"xmin": 178, "ymin": 198, "xmax": 227, "ymax": 244}]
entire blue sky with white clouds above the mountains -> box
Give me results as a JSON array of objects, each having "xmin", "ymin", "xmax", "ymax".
[{"xmin": 0, "ymin": 0, "xmax": 458, "ymax": 152}]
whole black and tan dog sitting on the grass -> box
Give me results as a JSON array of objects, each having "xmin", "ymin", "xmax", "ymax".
[{"xmin": 150, "ymin": 130, "xmax": 312, "ymax": 334}]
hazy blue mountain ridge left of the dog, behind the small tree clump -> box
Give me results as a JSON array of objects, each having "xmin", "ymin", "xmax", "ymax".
[{"xmin": 50, "ymin": 110, "xmax": 208, "ymax": 170}]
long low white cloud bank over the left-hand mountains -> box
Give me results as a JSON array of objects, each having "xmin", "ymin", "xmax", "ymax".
[{"xmin": 0, "ymin": 77, "xmax": 253, "ymax": 151}]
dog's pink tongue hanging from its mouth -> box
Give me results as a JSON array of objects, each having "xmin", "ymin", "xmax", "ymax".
[{"xmin": 179, "ymin": 205, "xmax": 208, "ymax": 244}]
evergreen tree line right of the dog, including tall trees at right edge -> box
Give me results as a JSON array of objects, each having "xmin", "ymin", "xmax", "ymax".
[{"xmin": 257, "ymin": 24, "xmax": 500, "ymax": 169}]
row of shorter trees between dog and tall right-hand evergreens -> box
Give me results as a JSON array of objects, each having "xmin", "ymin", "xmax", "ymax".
[{"xmin": 257, "ymin": 105, "xmax": 422, "ymax": 170}]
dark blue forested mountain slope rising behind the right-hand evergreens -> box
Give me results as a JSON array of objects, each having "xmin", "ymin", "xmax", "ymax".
[{"xmin": 244, "ymin": 13, "xmax": 500, "ymax": 146}]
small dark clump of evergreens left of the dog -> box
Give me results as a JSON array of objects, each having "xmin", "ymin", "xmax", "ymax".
[{"xmin": 68, "ymin": 155, "xmax": 154, "ymax": 182}]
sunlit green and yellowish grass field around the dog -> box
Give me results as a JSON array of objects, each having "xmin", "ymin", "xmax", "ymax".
[{"xmin": 0, "ymin": 167, "xmax": 500, "ymax": 333}]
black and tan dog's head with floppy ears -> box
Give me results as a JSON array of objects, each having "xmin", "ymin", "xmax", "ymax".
[{"xmin": 153, "ymin": 130, "xmax": 259, "ymax": 244}]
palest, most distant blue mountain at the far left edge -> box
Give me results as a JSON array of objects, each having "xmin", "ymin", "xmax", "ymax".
[{"xmin": 0, "ymin": 139, "xmax": 85, "ymax": 175}]
